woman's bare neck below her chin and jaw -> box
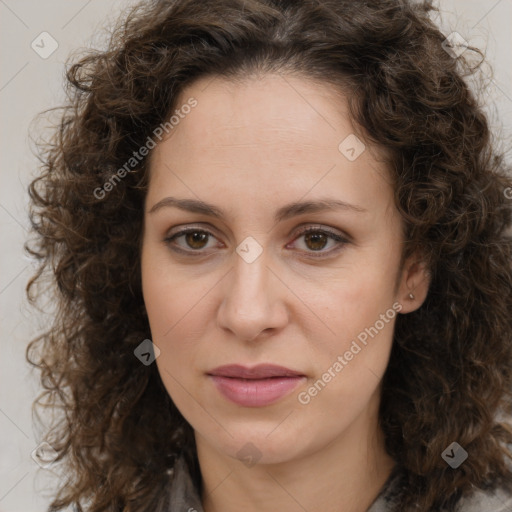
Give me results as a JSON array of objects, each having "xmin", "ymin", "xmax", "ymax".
[{"xmin": 196, "ymin": 394, "xmax": 394, "ymax": 512}]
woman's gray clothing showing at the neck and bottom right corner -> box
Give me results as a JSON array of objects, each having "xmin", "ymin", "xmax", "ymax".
[{"xmin": 169, "ymin": 458, "xmax": 512, "ymax": 512}]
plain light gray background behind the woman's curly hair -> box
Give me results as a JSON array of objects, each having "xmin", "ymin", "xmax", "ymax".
[{"xmin": 0, "ymin": 0, "xmax": 512, "ymax": 512}]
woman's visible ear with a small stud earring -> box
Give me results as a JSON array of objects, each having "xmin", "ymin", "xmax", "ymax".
[{"xmin": 397, "ymin": 254, "xmax": 430, "ymax": 314}]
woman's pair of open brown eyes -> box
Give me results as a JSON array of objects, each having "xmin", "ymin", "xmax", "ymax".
[{"xmin": 164, "ymin": 227, "xmax": 348, "ymax": 257}]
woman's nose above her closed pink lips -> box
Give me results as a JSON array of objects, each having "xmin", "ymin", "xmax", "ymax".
[{"xmin": 217, "ymin": 246, "xmax": 289, "ymax": 341}]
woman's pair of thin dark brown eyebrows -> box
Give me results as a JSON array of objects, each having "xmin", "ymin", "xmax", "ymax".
[{"xmin": 148, "ymin": 197, "xmax": 368, "ymax": 222}]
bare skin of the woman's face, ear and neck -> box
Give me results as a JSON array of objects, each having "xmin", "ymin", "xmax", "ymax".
[{"xmin": 141, "ymin": 75, "xmax": 428, "ymax": 512}]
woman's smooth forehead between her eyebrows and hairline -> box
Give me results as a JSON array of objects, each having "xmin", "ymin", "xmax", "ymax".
[{"xmin": 146, "ymin": 75, "xmax": 389, "ymax": 214}]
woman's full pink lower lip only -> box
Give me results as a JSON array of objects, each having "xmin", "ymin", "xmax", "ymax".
[{"xmin": 210, "ymin": 375, "xmax": 305, "ymax": 407}]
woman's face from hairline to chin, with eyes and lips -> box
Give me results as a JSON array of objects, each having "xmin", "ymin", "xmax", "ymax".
[{"xmin": 142, "ymin": 75, "xmax": 419, "ymax": 463}]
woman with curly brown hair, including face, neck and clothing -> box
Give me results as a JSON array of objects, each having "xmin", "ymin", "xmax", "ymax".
[{"xmin": 27, "ymin": 0, "xmax": 512, "ymax": 512}]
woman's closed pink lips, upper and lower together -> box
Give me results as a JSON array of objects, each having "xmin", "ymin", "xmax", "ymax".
[{"xmin": 208, "ymin": 364, "xmax": 305, "ymax": 407}]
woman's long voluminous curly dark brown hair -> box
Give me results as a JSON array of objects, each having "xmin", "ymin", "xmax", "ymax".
[{"xmin": 27, "ymin": 0, "xmax": 512, "ymax": 512}]
